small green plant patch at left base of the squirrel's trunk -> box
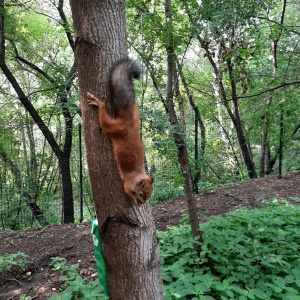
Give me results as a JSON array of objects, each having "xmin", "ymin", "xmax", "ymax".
[{"xmin": 48, "ymin": 257, "xmax": 107, "ymax": 300}]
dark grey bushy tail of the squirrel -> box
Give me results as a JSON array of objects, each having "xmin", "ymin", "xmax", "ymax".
[{"xmin": 109, "ymin": 57, "xmax": 142, "ymax": 110}]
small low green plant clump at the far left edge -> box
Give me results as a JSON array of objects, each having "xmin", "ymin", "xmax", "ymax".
[{"xmin": 0, "ymin": 252, "xmax": 29, "ymax": 277}]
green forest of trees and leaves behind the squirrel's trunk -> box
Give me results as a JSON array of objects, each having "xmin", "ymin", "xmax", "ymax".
[{"xmin": 0, "ymin": 0, "xmax": 300, "ymax": 229}]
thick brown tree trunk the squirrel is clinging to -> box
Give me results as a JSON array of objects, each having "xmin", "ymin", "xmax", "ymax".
[{"xmin": 70, "ymin": 0, "xmax": 163, "ymax": 300}]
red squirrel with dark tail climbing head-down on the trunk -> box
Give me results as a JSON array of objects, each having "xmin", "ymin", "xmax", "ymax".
[{"xmin": 87, "ymin": 58, "xmax": 154, "ymax": 206}]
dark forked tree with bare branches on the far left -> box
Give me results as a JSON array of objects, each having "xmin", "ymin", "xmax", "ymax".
[{"xmin": 0, "ymin": 0, "xmax": 75, "ymax": 223}]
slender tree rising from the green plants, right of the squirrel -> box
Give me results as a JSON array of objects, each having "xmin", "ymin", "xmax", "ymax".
[{"xmin": 126, "ymin": 0, "xmax": 205, "ymax": 246}]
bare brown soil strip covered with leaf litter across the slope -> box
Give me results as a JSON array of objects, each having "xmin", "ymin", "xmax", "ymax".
[{"xmin": 0, "ymin": 172, "xmax": 300, "ymax": 300}]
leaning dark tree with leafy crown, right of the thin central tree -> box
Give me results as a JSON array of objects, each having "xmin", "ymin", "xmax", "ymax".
[{"xmin": 184, "ymin": 1, "xmax": 257, "ymax": 178}]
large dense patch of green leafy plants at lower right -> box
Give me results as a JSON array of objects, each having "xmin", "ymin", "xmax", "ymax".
[{"xmin": 159, "ymin": 201, "xmax": 300, "ymax": 300}]
